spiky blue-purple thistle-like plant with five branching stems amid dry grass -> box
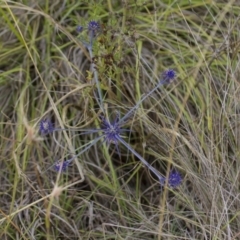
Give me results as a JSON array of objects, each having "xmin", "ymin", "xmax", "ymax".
[{"xmin": 40, "ymin": 21, "xmax": 182, "ymax": 188}]
